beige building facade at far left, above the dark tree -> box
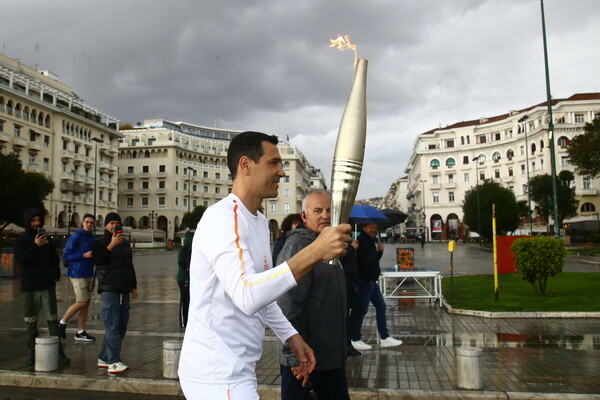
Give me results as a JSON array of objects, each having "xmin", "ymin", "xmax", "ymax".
[{"xmin": 0, "ymin": 54, "xmax": 121, "ymax": 232}]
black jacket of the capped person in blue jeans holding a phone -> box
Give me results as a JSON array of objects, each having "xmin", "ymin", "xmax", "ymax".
[{"xmin": 92, "ymin": 230, "xmax": 137, "ymax": 293}]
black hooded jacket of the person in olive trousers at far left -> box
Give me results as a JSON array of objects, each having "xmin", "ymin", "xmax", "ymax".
[{"xmin": 15, "ymin": 208, "xmax": 60, "ymax": 292}]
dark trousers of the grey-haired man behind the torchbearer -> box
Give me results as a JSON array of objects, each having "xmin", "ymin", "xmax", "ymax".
[{"xmin": 279, "ymin": 365, "xmax": 350, "ymax": 400}]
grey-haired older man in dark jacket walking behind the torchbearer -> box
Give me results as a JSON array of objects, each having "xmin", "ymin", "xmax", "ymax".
[{"xmin": 277, "ymin": 190, "xmax": 349, "ymax": 400}]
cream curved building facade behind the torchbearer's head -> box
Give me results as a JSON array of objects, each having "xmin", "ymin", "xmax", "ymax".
[{"xmin": 118, "ymin": 119, "xmax": 324, "ymax": 238}]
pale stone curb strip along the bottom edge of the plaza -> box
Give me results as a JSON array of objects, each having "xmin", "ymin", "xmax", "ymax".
[{"xmin": 0, "ymin": 370, "xmax": 600, "ymax": 400}]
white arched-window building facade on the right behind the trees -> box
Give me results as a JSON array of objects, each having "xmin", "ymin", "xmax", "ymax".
[{"xmin": 405, "ymin": 93, "xmax": 600, "ymax": 240}]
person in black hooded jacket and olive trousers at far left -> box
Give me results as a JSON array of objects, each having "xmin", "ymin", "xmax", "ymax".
[{"xmin": 15, "ymin": 208, "xmax": 70, "ymax": 365}]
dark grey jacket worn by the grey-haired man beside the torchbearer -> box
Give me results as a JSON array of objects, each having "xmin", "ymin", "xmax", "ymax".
[{"xmin": 277, "ymin": 227, "xmax": 347, "ymax": 371}]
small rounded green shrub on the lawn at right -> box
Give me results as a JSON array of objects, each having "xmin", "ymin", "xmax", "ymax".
[{"xmin": 511, "ymin": 236, "xmax": 567, "ymax": 295}]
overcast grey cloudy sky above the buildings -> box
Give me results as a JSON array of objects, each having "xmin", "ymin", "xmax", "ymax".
[{"xmin": 0, "ymin": 0, "xmax": 600, "ymax": 199}]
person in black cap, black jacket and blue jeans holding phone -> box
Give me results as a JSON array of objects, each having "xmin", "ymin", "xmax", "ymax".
[{"xmin": 92, "ymin": 212, "xmax": 138, "ymax": 374}]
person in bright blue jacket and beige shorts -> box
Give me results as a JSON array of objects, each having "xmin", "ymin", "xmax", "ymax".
[{"xmin": 58, "ymin": 214, "xmax": 96, "ymax": 342}]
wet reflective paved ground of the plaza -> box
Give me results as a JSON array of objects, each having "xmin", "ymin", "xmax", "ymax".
[{"xmin": 0, "ymin": 243, "xmax": 600, "ymax": 399}]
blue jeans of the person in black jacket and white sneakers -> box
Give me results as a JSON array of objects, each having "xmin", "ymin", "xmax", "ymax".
[{"xmin": 98, "ymin": 292, "xmax": 129, "ymax": 364}]
